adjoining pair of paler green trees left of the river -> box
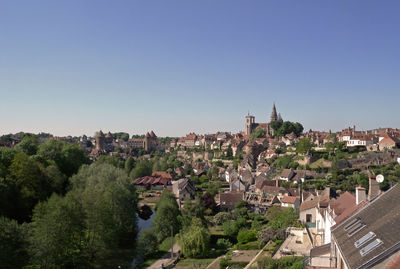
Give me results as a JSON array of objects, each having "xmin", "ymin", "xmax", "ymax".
[{"xmin": 30, "ymin": 164, "xmax": 137, "ymax": 268}]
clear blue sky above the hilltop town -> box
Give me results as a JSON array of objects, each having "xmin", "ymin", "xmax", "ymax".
[{"xmin": 0, "ymin": 0, "xmax": 400, "ymax": 136}]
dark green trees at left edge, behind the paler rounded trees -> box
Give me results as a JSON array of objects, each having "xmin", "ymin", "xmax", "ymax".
[{"xmin": 0, "ymin": 136, "xmax": 89, "ymax": 223}]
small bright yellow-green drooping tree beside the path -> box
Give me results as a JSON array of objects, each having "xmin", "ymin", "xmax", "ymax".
[{"xmin": 180, "ymin": 218, "xmax": 210, "ymax": 258}]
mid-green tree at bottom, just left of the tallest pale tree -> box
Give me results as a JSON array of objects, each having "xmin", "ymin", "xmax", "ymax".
[{"xmin": 29, "ymin": 195, "xmax": 87, "ymax": 268}]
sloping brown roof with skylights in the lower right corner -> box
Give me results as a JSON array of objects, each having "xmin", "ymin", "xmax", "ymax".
[{"xmin": 332, "ymin": 184, "xmax": 400, "ymax": 269}]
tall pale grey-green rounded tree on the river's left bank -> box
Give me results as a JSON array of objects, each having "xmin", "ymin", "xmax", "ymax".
[{"xmin": 71, "ymin": 164, "xmax": 137, "ymax": 252}]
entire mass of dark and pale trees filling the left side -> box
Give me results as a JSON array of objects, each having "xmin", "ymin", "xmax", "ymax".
[{"xmin": 0, "ymin": 136, "xmax": 137, "ymax": 268}]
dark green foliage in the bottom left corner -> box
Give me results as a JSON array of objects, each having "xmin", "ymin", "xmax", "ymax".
[{"xmin": 0, "ymin": 217, "xmax": 28, "ymax": 269}]
